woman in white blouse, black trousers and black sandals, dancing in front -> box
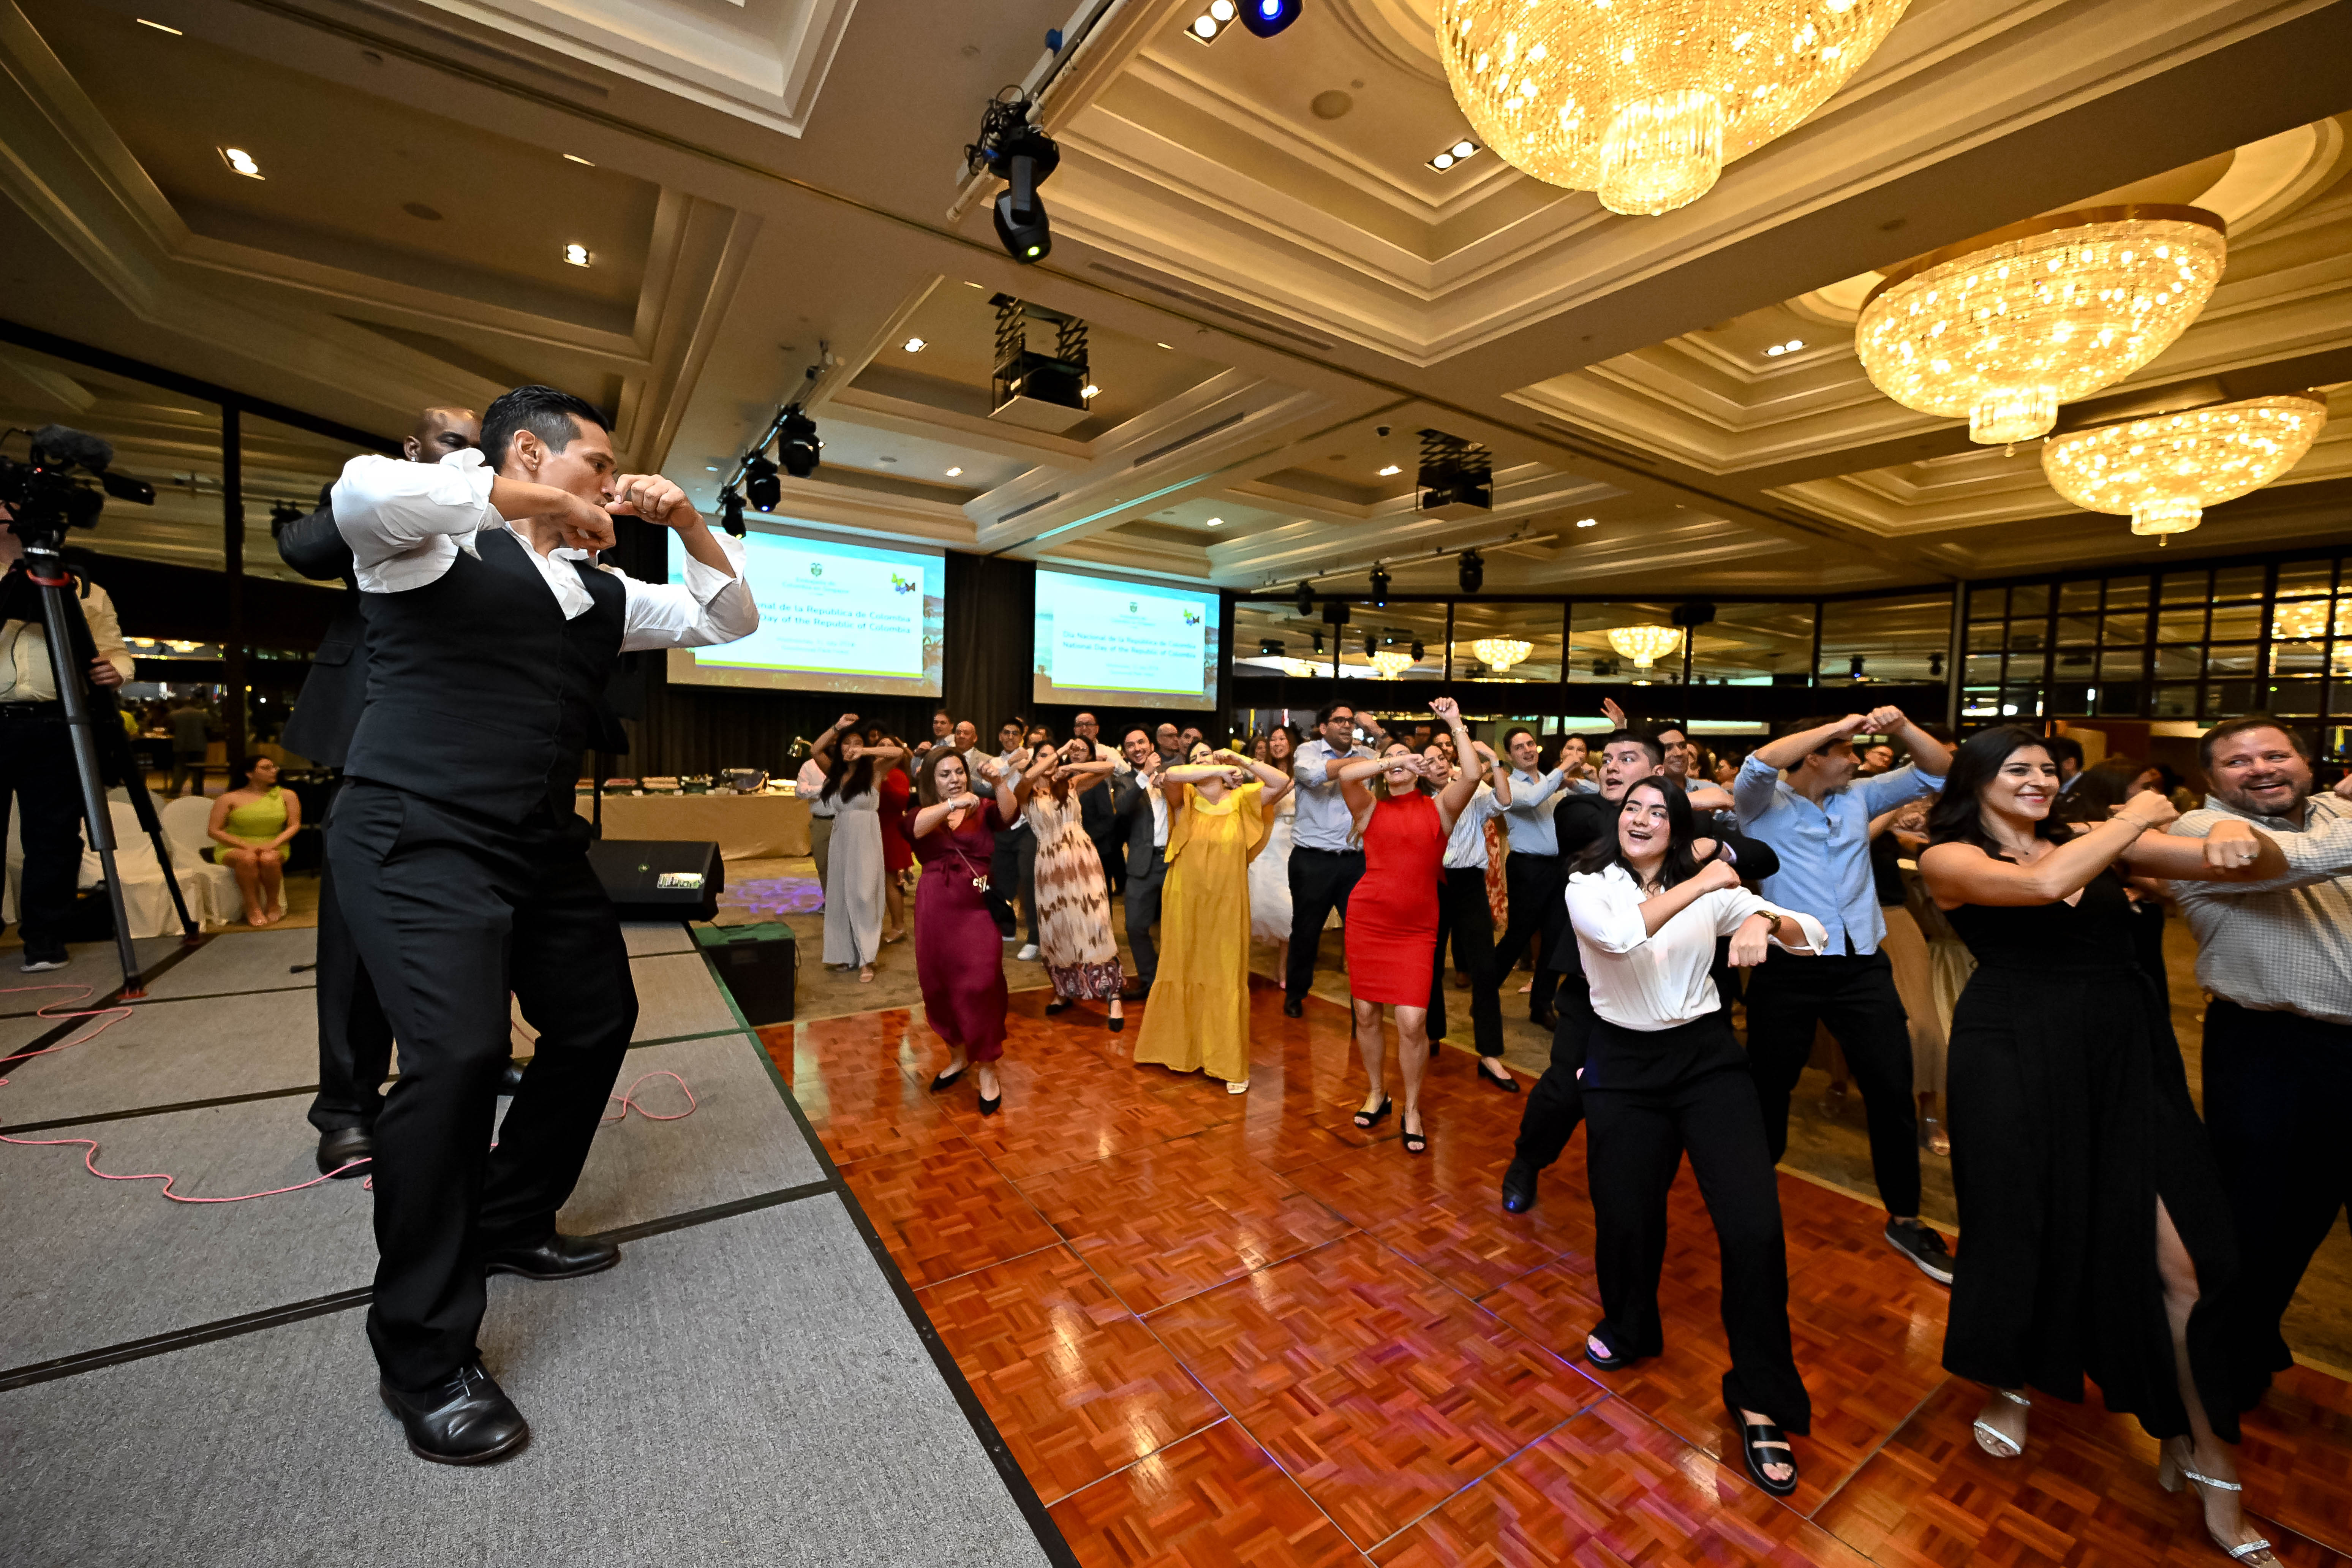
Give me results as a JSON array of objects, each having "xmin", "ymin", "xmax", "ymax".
[{"xmin": 1569, "ymin": 781, "xmax": 1825, "ymax": 1497}]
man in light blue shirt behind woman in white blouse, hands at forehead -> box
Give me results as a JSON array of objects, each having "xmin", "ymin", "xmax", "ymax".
[{"xmin": 1731, "ymin": 708, "xmax": 1952, "ymax": 1283}]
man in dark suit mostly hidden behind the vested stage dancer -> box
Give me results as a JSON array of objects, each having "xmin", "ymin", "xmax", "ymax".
[{"xmin": 278, "ymin": 409, "xmax": 482, "ymax": 1175}]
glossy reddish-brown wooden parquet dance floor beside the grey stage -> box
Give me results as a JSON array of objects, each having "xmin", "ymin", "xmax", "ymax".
[{"xmin": 762, "ymin": 985, "xmax": 2352, "ymax": 1568}]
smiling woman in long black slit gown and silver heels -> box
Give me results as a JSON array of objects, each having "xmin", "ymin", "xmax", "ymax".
[{"xmin": 1919, "ymin": 724, "xmax": 2284, "ymax": 1563}]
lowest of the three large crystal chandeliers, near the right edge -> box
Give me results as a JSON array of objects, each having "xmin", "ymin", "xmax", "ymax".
[{"xmin": 2042, "ymin": 393, "xmax": 2328, "ymax": 545}]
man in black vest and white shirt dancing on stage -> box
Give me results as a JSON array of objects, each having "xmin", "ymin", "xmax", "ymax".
[{"xmin": 327, "ymin": 386, "xmax": 760, "ymax": 1465}]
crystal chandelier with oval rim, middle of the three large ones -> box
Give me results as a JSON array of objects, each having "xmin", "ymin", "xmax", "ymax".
[{"xmin": 1853, "ymin": 207, "xmax": 2227, "ymax": 447}]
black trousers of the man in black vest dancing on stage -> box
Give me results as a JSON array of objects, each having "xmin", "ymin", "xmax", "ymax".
[{"xmin": 327, "ymin": 778, "xmax": 637, "ymax": 1387}]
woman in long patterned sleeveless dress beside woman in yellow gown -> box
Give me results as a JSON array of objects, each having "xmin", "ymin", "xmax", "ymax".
[{"xmin": 997, "ymin": 741, "xmax": 1127, "ymax": 1032}]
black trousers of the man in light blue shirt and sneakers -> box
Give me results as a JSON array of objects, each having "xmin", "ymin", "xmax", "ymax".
[{"xmin": 1748, "ymin": 950, "xmax": 1919, "ymax": 1220}]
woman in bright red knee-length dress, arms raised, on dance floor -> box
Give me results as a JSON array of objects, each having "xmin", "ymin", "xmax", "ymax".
[{"xmin": 1331, "ymin": 696, "xmax": 1477, "ymax": 1154}]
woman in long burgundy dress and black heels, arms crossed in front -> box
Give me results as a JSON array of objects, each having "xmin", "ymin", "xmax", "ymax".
[{"xmin": 906, "ymin": 745, "xmax": 1004, "ymax": 1117}]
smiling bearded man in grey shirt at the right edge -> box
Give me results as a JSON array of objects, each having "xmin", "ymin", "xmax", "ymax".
[{"xmin": 2171, "ymin": 714, "xmax": 2352, "ymax": 1408}]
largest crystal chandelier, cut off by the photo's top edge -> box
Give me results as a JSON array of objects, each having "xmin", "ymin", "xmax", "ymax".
[{"xmin": 1437, "ymin": 0, "xmax": 1908, "ymax": 214}]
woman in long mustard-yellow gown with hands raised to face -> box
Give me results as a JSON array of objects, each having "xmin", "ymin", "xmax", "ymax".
[{"xmin": 1136, "ymin": 752, "xmax": 1291, "ymax": 1093}]
